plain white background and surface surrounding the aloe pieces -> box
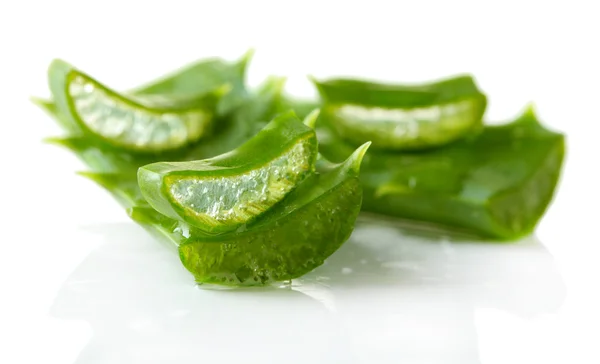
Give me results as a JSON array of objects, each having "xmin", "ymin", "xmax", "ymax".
[{"xmin": 0, "ymin": 0, "xmax": 600, "ymax": 363}]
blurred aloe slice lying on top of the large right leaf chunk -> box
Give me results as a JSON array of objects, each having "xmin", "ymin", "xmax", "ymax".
[{"xmin": 314, "ymin": 76, "xmax": 486, "ymax": 150}]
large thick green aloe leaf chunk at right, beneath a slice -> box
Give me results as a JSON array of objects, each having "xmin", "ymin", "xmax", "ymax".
[{"xmin": 319, "ymin": 109, "xmax": 565, "ymax": 240}]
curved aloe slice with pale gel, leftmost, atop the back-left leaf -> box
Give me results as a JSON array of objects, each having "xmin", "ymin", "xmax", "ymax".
[{"xmin": 49, "ymin": 60, "xmax": 230, "ymax": 153}]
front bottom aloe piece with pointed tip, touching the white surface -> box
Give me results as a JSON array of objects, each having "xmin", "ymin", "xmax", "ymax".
[{"xmin": 130, "ymin": 143, "xmax": 369, "ymax": 285}]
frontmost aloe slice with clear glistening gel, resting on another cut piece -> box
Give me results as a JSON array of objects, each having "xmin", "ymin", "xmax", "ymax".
[{"xmin": 138, "ymin": 113, "xmax": 317, "ymax": 233}]
